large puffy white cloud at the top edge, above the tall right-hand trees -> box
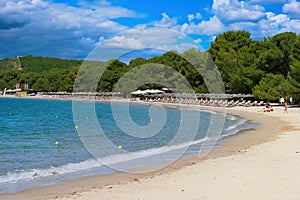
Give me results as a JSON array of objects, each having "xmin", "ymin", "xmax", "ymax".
[{"xmin": 212, "ymin": 0, "xmax": 264, "ymax": 22}]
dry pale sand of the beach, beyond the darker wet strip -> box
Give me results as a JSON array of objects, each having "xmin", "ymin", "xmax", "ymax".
[{"xmin": 55, "ymin": 107, "xmax": 300, "ymax": 200}]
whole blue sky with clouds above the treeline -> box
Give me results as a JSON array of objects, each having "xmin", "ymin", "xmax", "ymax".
[{"xmin": 0, "ymin": 0, "xmax": 300, "ymax": 59}]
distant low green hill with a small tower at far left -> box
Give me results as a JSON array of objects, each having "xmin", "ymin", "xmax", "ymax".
[{"xmin": 0, "ymin": 55, "xmax": 83, "ymax": 72}]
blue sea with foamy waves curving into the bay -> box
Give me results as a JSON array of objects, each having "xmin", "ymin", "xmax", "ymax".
[{"xmin": 0, "ymin": 98, "xmax": 259, "ymax": 193}]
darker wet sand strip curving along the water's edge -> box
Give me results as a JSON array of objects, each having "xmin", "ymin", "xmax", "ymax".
[{"xmin": 0, "ymin": 97, "xmax": 296, "ymax": 199}]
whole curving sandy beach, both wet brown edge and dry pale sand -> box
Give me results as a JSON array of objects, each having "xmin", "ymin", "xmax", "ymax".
[{"xmin": 0, "ymin": 99, "xmax": 300, "ymax": 200}]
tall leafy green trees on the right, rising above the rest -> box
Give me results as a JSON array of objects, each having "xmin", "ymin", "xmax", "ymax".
[{"xmin": 208, "ymin": 31, "xmax": 300, "ymax": 100}]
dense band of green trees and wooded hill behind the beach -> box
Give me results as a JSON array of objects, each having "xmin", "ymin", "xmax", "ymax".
[{"xmin": 0, "ymin": 31, "xmax": 300, "ymax": 100}]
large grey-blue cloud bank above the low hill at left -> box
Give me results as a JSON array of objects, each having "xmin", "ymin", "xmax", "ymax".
[{"xmin": 0, "ymin": 0, "xmax": 137, "ymax": 58}]
